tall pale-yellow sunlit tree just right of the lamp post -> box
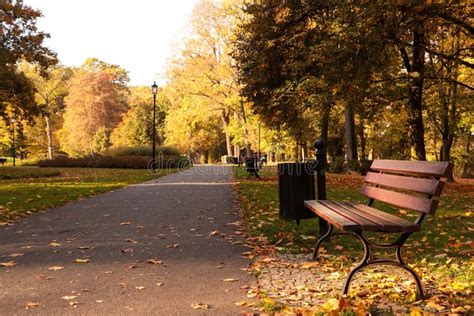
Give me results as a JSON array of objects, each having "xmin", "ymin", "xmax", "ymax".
[{"xmin": 168, "ymin": 0, "xmax": 256, "ymax": 156}]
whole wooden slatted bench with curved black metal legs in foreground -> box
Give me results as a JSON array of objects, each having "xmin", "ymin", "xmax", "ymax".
[{"xmin": 305, "ymin": 160, "xmax": 452, "ymax": 298}]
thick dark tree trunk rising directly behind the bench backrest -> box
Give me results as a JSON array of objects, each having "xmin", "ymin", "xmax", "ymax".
[{"xmin": 407, "ymin": 25, "xmax": 426, "ymax": 160}]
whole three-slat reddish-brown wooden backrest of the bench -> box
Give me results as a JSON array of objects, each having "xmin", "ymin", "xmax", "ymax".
[{"xmin": 361, "ymin": 160, "xmax": 452, "ymax": 214}]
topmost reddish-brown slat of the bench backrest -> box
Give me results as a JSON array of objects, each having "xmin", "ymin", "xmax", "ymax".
[{"xmin": 370, "ymin": 160, "xmax": 452, "ymax": 177}]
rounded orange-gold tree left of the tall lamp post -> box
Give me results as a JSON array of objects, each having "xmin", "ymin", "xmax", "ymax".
[{"xmin": 59, "ymin": 59, "xmax": 128, "ymax": 156}]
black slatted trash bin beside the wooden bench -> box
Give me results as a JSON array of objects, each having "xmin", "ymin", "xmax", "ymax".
[{"xmin": 278, "ymin": 161, "xmax": 317, "ymax": 221}]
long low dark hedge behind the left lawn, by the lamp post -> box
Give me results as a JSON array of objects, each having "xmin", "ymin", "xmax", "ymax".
[{"xmin": 38, "ymin": 155, "xmax": 190, "ymax": 169}]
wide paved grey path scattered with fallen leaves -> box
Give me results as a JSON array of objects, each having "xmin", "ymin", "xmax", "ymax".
[{"xmin": 0, "ymin": 166, "xmax": 254, "ymax": 315}]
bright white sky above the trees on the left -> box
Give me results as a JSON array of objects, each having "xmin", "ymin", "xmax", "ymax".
[{"xmin": 24, "ymin": 0, "xmax": 198, "ymax": 85}]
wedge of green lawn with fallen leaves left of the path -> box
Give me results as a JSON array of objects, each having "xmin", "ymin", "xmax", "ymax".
[{"xmin": 0, "ymin": 167, "xmax": 175, "ymax": 222}]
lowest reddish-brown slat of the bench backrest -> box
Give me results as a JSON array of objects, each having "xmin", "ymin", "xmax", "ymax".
[{"xmin": 361, "ymin": 184, "xmax": 438, "ymax": 214}]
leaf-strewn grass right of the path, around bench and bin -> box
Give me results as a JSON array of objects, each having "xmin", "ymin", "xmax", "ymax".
[{"xmin": 236, "ymin": 167, "xmax": 474, "ymax": 310}]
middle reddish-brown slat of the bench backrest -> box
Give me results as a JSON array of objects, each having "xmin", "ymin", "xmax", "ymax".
[{"xmin": 365, "ymin": 172, "xmax": 444, "ymax": 196}]
